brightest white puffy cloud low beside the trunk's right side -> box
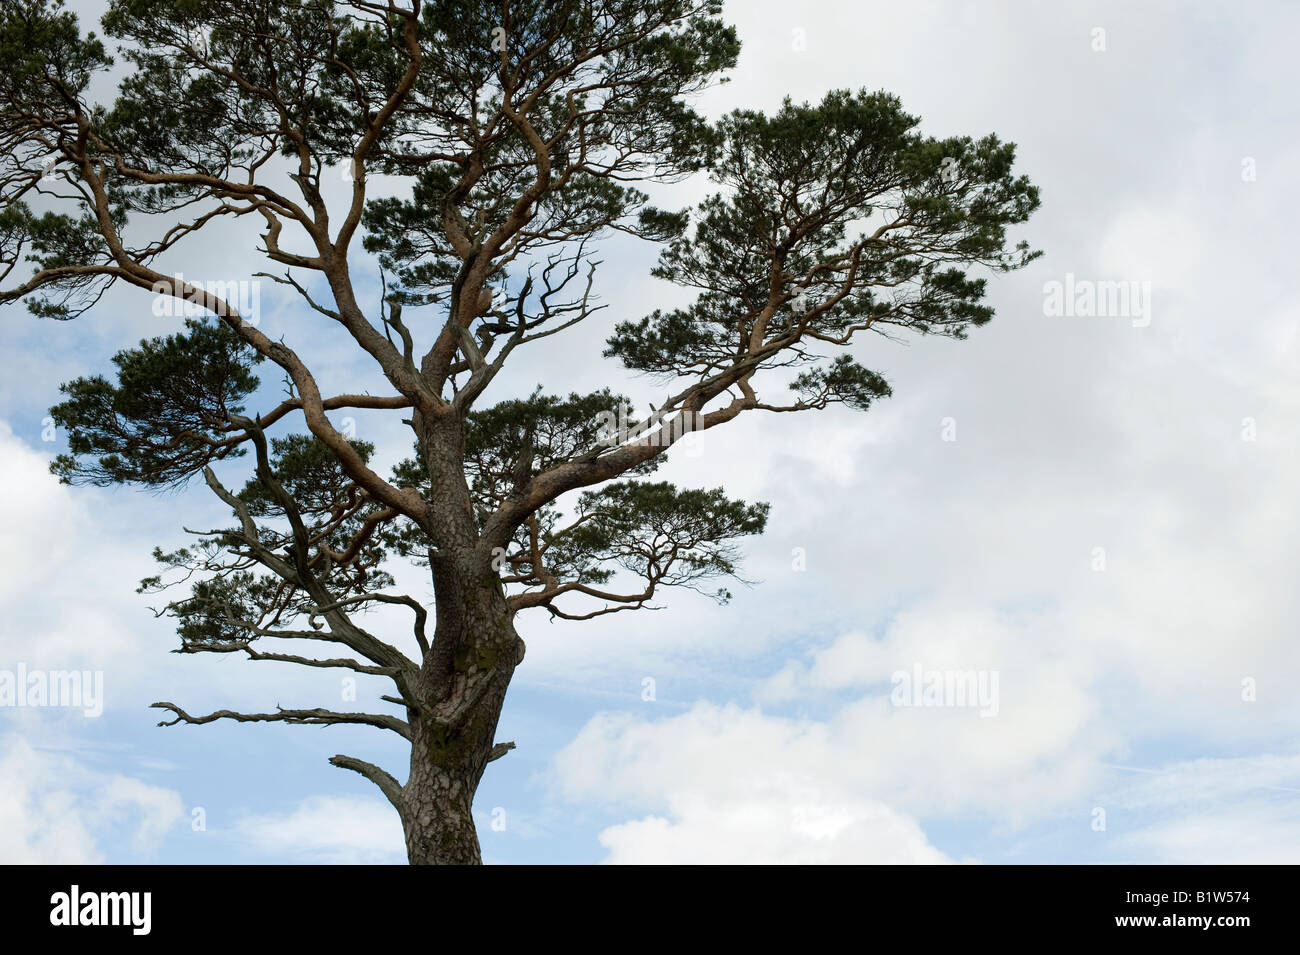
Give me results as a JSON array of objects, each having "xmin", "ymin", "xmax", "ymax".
[{"xmin": 555, "ymin": 704, "xmax": 949, "ymax": 864}]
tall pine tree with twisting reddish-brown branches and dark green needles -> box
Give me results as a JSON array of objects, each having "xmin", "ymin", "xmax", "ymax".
[{"xmin": 0, "ymin": 0, "xmax": 1039, "ymax": 863}]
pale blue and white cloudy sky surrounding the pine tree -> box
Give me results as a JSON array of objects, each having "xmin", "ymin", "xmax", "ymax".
[{"xmin": 0, "ymin": 0, "xmax": 1300, "ymax": 864}]
